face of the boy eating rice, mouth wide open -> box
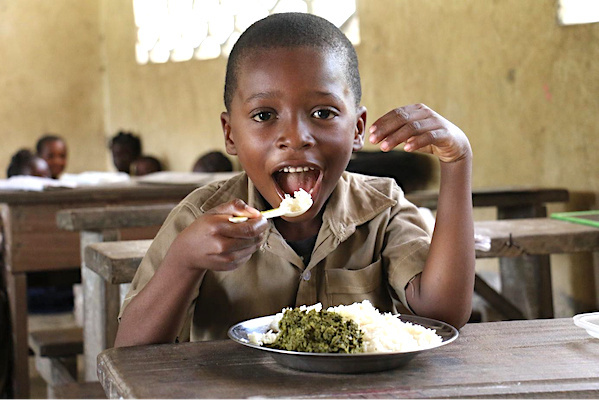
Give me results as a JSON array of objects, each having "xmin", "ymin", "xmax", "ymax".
[{"xmin": 221, "ymin": 47, "xmax": 366, "ymax": 222}]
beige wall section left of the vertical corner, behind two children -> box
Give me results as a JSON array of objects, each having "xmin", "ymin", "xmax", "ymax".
[{"xmin": 0, "ymin": 0, "xmax": 107, "ymax": 174}]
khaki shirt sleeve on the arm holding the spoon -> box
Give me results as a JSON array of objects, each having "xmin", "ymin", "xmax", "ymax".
[{"xmin": 118, "ymin": 200, "xmax": 201, "ymax": 342}]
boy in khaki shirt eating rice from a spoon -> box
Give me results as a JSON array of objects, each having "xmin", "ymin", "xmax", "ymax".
[{"xmin": 115, "ymin": 13, "xmax": 474, "ymax": 346}]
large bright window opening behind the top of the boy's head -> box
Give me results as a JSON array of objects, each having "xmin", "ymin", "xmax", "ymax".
[{"xmin": 133, "ymin": 0, "xmax": 360, "ymax": 64}]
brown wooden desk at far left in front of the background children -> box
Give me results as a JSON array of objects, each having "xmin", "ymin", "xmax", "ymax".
[{"xmin": 0, "ymin": 182, "xmax": 198, "ymax": 398}]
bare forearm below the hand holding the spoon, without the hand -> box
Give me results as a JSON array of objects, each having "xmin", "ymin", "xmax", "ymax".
[{"xmin": 115, "ymin": 247, "xmax": 205, "ymax": 347}]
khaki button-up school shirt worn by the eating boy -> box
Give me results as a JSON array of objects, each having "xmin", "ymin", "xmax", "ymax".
[{"xmin": 121, "ymin": 172, "xmax": 430, "ymax": 341}]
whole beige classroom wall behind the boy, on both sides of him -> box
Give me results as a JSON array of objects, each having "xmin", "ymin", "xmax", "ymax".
[{"xmin": 0, "ymin": 0, "xmax": 599, "ymax": 313}]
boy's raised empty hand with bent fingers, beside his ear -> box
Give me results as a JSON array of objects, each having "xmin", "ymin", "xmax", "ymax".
[{"xmin": 370, "ymin": 104, "xmax": 472, "ymax": 163}]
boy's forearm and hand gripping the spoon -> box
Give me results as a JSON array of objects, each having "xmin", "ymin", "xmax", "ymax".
[{"xmin": 115, "ymin": 200, "xmax": 268, "ymax": 347}]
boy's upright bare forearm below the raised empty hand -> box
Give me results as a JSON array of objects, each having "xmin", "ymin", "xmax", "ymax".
[{"xmin": 410, "ymin": 155, "xmax": 475, "ymax": 327}]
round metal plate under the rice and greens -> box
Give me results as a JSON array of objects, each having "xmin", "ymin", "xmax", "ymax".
[{"xmin": 228, "ymin": 315, "xmax": 458, "ymax": 374}]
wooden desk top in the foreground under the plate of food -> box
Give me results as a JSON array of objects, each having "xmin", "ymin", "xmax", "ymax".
[{"xmin": 98, "ymin": 318, "xmax": 599, "ymax": 398}]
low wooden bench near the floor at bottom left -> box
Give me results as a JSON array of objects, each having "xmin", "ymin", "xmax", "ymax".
[{"xmin": 29, "ymin": 327, "xmax": 105, "ymax": 399}]
